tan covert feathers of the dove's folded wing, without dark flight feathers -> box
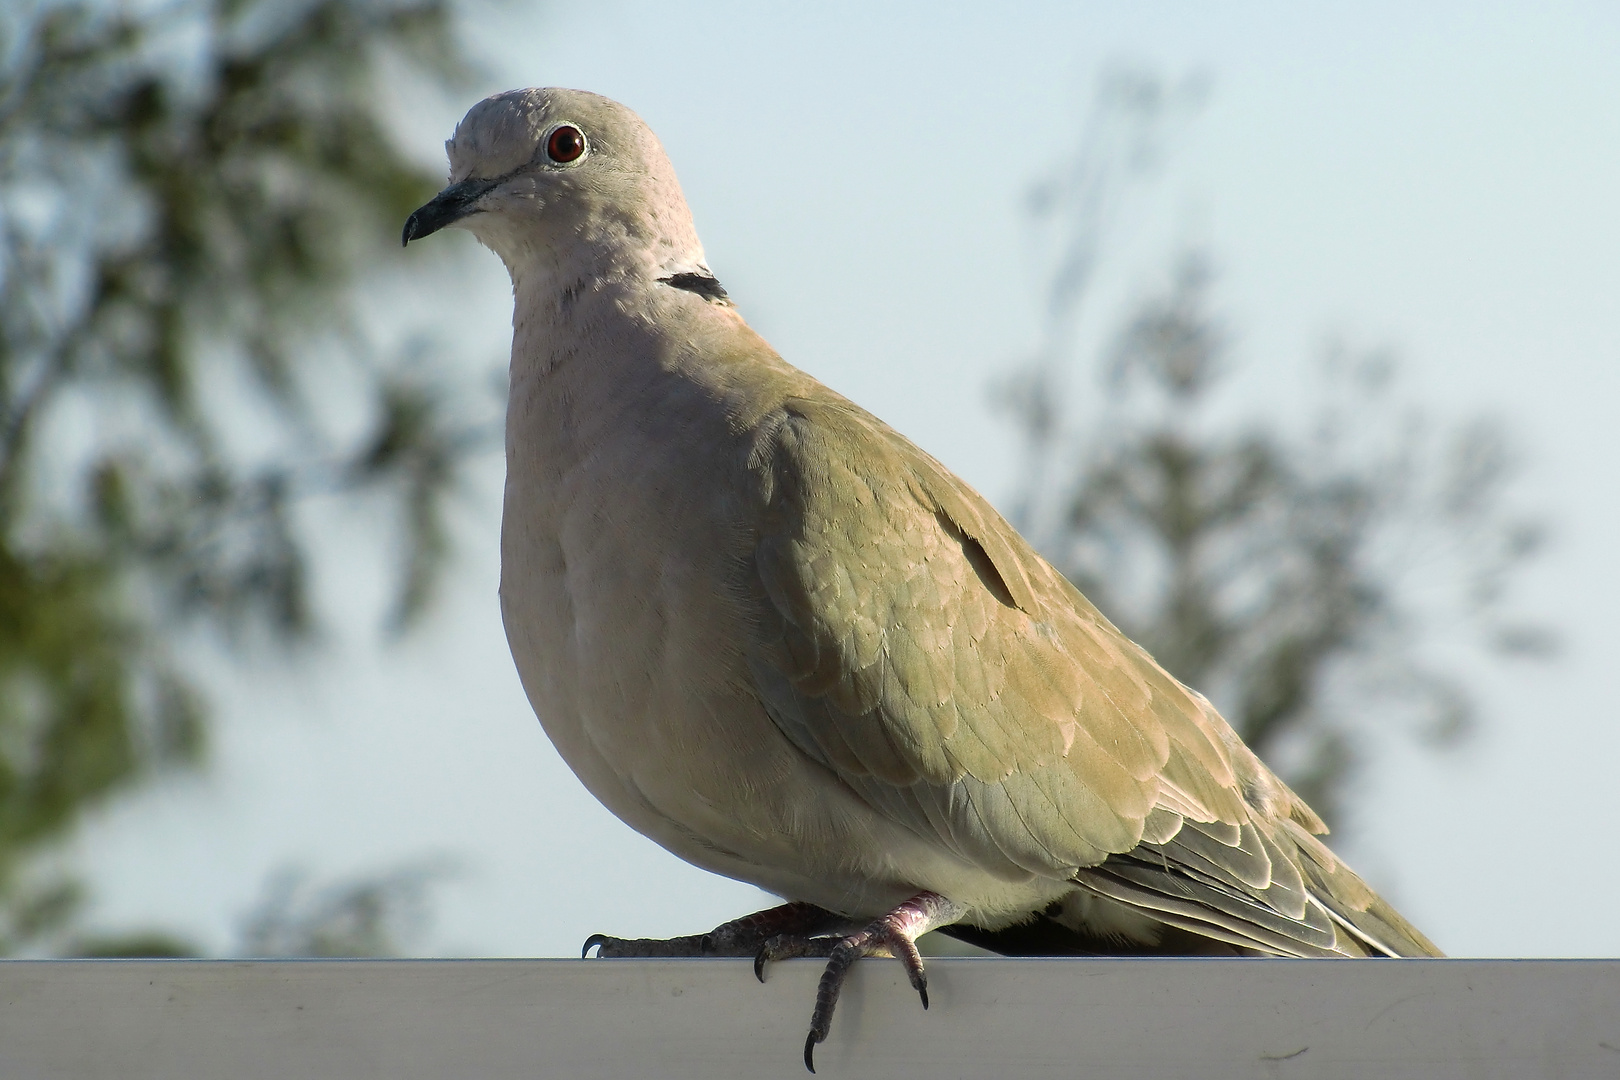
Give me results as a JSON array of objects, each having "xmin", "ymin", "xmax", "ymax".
[{"xmin": 753, "ymin": 398, "xmax": 1243, "ymax": 873}]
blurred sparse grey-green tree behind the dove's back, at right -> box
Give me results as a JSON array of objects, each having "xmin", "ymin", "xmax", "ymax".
[{"xmin": 1001, "ymin": 73, "xmax": 1555, "ymax": 821}]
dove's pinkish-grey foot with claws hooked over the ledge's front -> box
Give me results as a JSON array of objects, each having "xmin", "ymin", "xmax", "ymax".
[{"xmin": 753, "ymin": 892, "xmax": 966, "ymax": 1072}]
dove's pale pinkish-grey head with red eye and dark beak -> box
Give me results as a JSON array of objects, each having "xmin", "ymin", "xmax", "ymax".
[{"xmin": 403, "ymin": 87, "xmax": 703, "ymax": 277}]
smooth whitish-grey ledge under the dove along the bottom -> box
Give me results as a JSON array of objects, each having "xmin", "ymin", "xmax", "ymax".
[{"xmin": 0, "ymin": 957, "xmax": 1620, "ymax": 1080}]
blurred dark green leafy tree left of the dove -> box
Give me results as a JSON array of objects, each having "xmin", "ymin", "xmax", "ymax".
[{"xmin": 0, "ymin": 0, "xmax": 489, "ymax": 950}]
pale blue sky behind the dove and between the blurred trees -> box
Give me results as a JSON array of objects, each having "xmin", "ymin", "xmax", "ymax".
[{"xmin": 75, "ymin": 0, "xmax": 1620, "ymax": 955}]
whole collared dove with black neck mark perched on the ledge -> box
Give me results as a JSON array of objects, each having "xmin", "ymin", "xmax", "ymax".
[{"xmin": 403, "ymin": 89, "xmax": 1439, "ymax": 1070}]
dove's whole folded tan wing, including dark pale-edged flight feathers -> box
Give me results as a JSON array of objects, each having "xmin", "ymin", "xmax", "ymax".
[{"xmin": 750, "ymin": 393, "xmax": 1432, "ymax": 955}]
